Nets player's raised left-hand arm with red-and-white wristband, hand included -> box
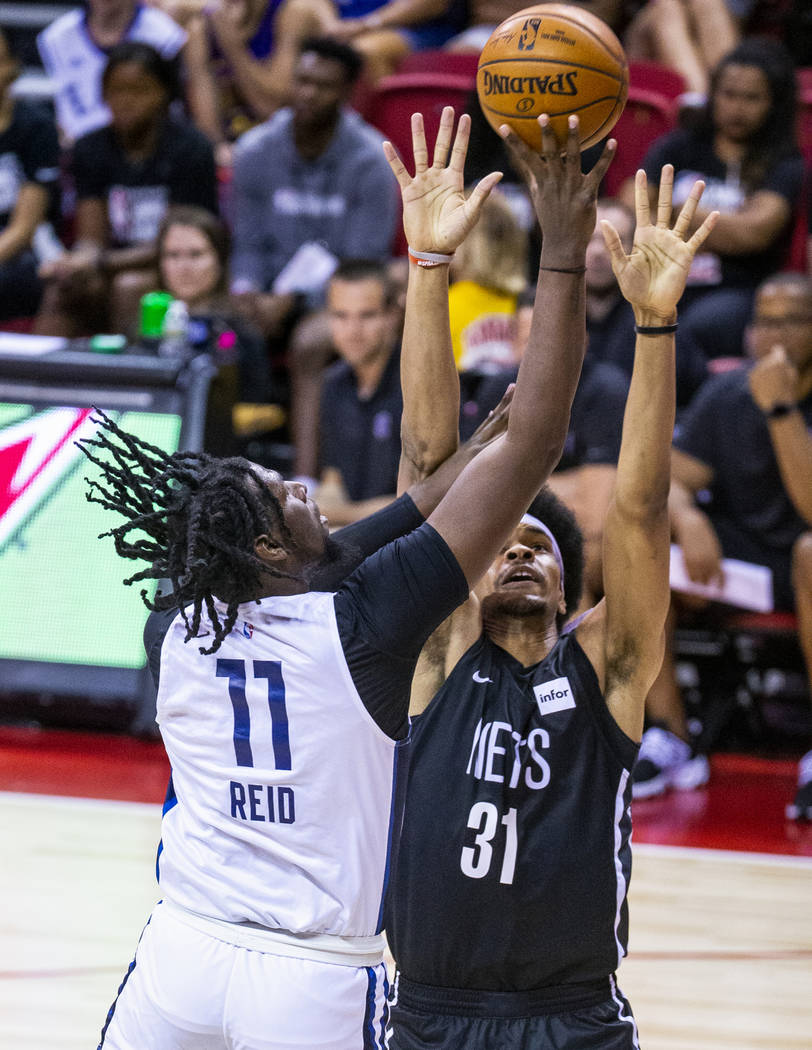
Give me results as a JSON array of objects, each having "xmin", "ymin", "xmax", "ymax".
[{"xmin": 383, "ymin": 106, "xmax": 501, "ymax": 491}]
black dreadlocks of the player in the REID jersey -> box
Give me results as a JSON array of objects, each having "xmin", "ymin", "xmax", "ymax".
[{"xmin": 77, "ymin": 408, "xmax": 298, "ymax": 654}]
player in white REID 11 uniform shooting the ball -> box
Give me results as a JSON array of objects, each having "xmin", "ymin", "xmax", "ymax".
[{"xmin": 79, "ymin": 108, "xmax": 613, "ymax": 1050}]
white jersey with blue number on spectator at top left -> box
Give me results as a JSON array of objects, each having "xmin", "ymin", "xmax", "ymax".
[{"xmin": 37, "ymin": 4, "xmax": 186, "ymax": 141}]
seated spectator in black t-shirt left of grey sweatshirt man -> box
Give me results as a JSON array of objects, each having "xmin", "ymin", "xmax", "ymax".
[{"xmin": 37, "ymin": 42, "xmax": 217, "ymax": 336}]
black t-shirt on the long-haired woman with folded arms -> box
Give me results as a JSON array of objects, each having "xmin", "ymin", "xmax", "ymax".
[{"xmin": 643, "ymin": 129, "xmax": 804, "ymax": 288}]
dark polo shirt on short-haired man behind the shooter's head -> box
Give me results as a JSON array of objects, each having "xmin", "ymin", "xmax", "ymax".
[{"xmin": 319, "ymin": 351, "xmax": 403, "ymax": 500}]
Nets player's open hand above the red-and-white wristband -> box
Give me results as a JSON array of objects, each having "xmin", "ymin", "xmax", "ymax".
[{"xmin": 383, "ymin": 106, "xmax": 502, "ymax": 254}]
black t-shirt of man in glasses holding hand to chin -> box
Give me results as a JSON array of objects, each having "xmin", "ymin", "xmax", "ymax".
[{"xmin": 673, "ymin": 370, "xmax": 812, "ymax": 551}]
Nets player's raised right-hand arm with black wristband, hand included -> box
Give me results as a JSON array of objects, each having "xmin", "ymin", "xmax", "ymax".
[{"xmin": 579, "ymin": 165, "xmax": 715, "ymax": 740}]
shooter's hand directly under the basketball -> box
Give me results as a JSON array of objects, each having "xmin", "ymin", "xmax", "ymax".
[{"xmin": 499, "ymin": 113, "xmax": 618, "ymax": 266}]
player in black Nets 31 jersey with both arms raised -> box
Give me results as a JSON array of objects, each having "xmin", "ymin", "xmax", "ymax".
[{"xmin": 387, "ymin": 108, "xmax": 715, "ymax": 1050}]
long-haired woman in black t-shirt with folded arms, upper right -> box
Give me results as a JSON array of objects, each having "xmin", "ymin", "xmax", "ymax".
[{"xmin": 643, "ymin": 40, "xmax": 804, "ymax": 369}]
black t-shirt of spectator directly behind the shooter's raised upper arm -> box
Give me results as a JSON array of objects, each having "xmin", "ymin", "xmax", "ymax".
[{"xmin": 460, "ymin": 352, "xmax": 633, "ymax": 470}]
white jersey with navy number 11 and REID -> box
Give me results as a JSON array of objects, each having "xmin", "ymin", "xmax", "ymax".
[{"xmin": 158, "ymin": 592, "xmax": 400, "ymax": 937}]
